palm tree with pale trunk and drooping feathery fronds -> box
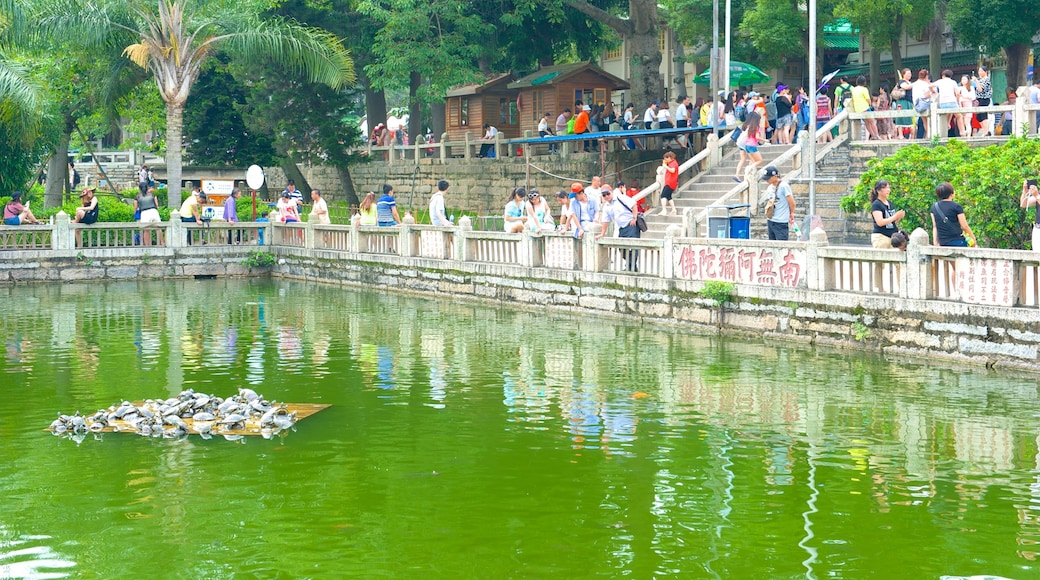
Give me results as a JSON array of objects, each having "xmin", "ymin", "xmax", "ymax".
[{"xmin": 35, "ymin": 0, "xmax": 355, "ymax": 208}]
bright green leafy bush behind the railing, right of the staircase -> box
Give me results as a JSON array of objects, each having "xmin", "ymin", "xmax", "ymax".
[{"xmin": 841, "ymin": 138, "xmax": 1040, "ymax": 249}]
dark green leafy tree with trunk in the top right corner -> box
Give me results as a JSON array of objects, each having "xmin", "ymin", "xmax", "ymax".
[{"xmin": 946, "ymin": 0, "xmax": 1040, "ymax": 86}]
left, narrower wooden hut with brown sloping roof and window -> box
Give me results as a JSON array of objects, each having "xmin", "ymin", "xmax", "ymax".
[{"xmin": 445, "ymin": 73, "xmax": 520, "ymax": 141}]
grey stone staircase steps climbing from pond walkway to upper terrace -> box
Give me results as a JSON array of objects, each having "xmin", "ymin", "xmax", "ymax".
[{"xmin": 642, "ymin": 146, "xmax": 788, "ymax": 239}]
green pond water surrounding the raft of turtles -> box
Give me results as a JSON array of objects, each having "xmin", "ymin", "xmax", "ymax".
[{"xmin": 0, "ymin": 281, "xmax": 1040, "ymax": 579}]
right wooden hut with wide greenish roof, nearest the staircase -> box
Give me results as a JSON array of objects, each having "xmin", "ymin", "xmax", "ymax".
[{"xmin": 508, "ymin": 62, "xmax": 630, "ymax": 135}]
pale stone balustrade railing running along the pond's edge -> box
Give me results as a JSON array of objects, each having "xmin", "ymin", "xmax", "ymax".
[{"xmin": 0, "ymin": 214, "xmax": 1040, "ymax": 308}]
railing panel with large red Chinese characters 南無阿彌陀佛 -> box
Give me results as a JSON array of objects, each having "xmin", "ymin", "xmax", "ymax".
[{"xmin": 675, "ymin": 245, "xmax": 806, "ymax": 288}]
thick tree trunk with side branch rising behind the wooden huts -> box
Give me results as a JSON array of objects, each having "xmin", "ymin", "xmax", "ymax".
[{"xmin": 564, "ymin": 0, "xmax": 665, "ymax": 106}]
